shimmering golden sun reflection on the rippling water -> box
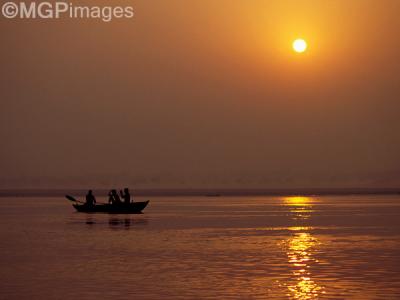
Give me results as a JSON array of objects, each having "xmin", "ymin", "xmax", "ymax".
[{"xmin": 284, "ymin": 197, "xmax": 325, "ymax": 299}]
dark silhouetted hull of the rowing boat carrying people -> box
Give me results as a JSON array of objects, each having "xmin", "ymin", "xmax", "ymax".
[{"xmin": 73, "ymin": 201, "xmax": 149, "ymax": 214}]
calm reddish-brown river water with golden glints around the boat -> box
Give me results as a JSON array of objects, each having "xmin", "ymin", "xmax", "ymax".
[{"xmin": 0, "ymin": 195, "xmax": 400, "ymax": 299}]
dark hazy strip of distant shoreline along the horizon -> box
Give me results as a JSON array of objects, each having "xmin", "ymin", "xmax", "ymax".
[{"xmin": 0, "ymin": 188, "xmax": 400, "ymax": 197}]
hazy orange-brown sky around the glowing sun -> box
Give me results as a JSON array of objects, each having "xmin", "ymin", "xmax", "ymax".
[{"xmin": 0, "ymin": 0, "xmax": 400, "ymax": 188}]
